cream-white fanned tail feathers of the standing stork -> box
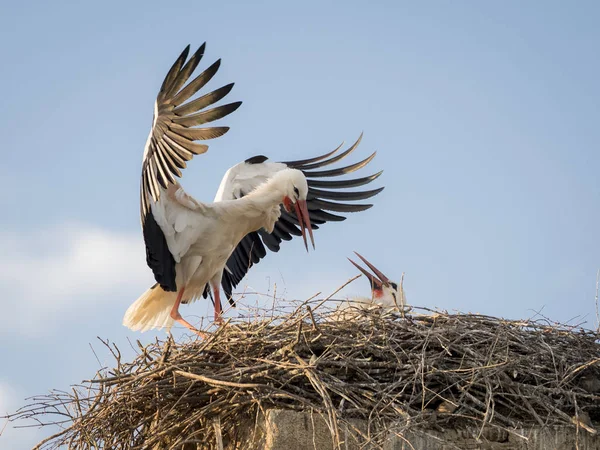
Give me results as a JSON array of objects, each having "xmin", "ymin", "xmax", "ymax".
[{"xmin": 123, "ymin": 285, "xmax": 177, "ymax": 331}]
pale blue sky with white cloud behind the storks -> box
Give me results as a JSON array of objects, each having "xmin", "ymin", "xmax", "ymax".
[{"xmin": 0, "ymin": 1, "xmax": 600, "ymax": 448}]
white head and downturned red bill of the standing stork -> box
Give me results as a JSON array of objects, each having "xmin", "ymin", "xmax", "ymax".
[{"xmin": 276, "ymin": 169, "xmax": 315, "ymax": 251}]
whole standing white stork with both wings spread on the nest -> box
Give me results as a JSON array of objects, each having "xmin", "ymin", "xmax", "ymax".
[{"xmin": 123, "ymin": 44, "xmax": 383, "ymax": 334}]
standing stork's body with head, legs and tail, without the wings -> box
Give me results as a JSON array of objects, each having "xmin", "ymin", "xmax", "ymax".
[{"xmin": 123, "ymin": 169, "xmax": 314, "ymax": 331}]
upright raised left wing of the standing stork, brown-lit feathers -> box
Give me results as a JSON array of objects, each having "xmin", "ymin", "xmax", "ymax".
[{"xmin": 140, "ymin": 43, "xmax": 241, "ymax": 291}]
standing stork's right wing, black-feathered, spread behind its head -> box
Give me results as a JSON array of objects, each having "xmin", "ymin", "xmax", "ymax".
[{"xmin": 216, "ymin": 134, "xmax": 383, "ymax": 305}]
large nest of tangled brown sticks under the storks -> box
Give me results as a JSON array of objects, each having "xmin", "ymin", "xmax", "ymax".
[{"xmin": 11, "ymin": 303, "xmax": 600, "ymax": 449}]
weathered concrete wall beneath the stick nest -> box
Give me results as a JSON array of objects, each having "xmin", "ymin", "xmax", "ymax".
[{"xmin": 247, "ymin": 410, "xmax": 600, "ymax": 450}]
